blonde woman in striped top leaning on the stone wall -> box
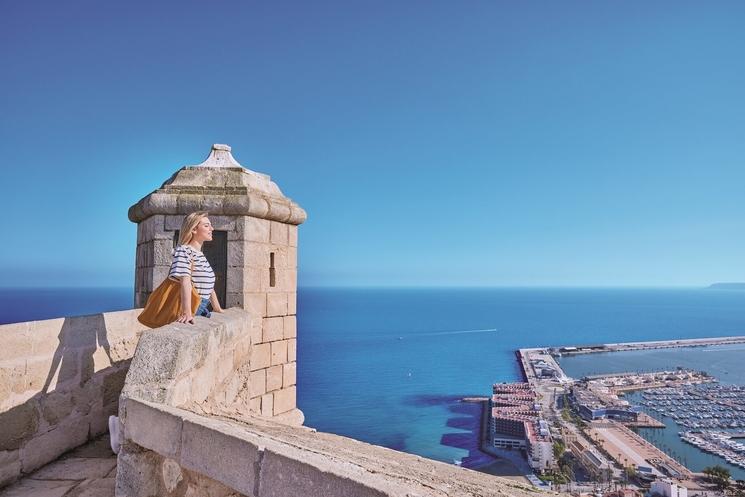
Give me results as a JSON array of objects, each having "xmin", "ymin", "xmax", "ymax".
[{"xmin": 168, "ymin": 211, "xmax": 222, "ymax": 324}]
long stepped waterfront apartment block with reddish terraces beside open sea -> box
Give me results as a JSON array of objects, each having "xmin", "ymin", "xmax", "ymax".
[{"xmin": 490, "ymin": 383, "xmax": 555, "ymax": 471}]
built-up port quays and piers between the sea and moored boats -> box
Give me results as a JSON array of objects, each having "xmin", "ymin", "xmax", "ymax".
[{"xmin": 517, "ymin": 349, "xmax": 696, "ymax": 481}]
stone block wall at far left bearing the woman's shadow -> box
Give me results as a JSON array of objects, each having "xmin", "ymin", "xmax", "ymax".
[{"xmin": 0, "ymin": 310, "xmax": 144, "ymax": 487}]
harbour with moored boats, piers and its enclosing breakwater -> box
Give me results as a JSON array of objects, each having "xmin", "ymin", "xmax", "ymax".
[{"xmin": 517, "ymin": 336, "xmax": 745, "ymax": 479}]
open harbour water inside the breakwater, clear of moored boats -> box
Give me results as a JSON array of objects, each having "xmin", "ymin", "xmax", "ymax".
[{"xmin": 559, "ymin": 344, "xmax": 745, "ymax": 479}]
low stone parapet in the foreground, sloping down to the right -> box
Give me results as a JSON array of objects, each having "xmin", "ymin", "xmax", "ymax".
[{"xmin": 116, "ymin": 398, "xmax": 556, "ymax": 497}]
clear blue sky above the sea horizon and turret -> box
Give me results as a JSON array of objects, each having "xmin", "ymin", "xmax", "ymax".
[{"xmin": 0, "ymin": 1, "xmax": 745, "ymax": 287}]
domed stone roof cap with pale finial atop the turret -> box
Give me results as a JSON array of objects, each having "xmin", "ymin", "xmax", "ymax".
[{"xmin": 128, "ymin": 144, "xmax": 307, "ymax": 225}]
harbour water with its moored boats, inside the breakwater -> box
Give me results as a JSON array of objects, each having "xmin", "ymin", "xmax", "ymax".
[{"xmin": 559, "ymin": 337, "xmax": 745, "ymax": 479}]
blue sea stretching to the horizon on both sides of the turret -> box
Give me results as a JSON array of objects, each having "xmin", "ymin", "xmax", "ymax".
[{"xmin": 0, "ymin": 287, "xmax": 745, "ymax": 469}]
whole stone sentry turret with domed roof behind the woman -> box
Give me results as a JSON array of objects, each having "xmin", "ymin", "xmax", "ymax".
[{"xmin": 129, "ymin": 144, "xmax": 306, "ymax": 416}]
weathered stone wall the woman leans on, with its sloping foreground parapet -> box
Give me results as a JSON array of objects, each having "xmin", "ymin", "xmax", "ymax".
[{"xmin": 116, "ymin": 308, "xmax": 540, "ymax": 497}]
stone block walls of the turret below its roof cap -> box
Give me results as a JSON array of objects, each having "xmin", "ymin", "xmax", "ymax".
[{"xmin": 135, "ymin": 214, "xmax": 301, "ymax": 419}]
